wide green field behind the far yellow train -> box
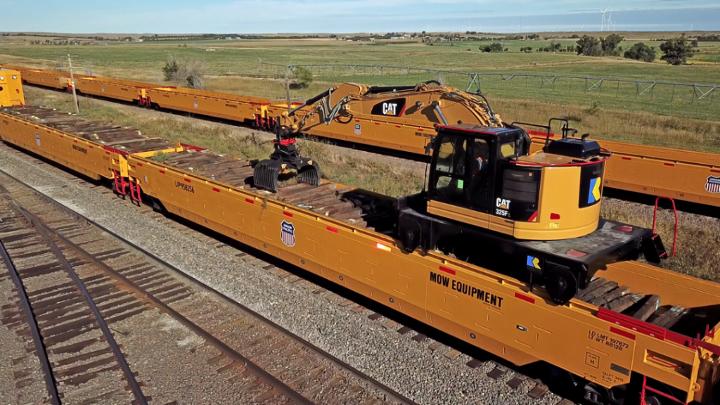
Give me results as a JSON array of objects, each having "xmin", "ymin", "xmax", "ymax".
[{"xmin": 0, "ymin": 34, "xmax": 720, "ymax": 151}]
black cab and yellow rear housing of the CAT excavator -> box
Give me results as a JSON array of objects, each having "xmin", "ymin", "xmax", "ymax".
[{"xmin": 427, "ymin": 125, "xmax": 605, "ymax": 240}]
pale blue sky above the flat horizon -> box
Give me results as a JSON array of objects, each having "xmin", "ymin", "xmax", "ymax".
[{"xmin": 0, "ymin": 0, "xmax": 720, "ymax": 34}]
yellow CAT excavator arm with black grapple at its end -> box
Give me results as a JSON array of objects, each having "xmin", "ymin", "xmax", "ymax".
[{"xmin": 254, "ymin": 81, "xmax": 505, "ymax": 191}]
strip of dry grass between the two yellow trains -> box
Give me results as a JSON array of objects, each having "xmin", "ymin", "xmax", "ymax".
[{"xmin": 22, "ymin": 89, "xmax": 720, "ymax": 281}]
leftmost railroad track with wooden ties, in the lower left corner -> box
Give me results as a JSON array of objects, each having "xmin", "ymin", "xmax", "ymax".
[{"xmin": 0, "ymin": 186, "xmax": 147, "ymax": 404}]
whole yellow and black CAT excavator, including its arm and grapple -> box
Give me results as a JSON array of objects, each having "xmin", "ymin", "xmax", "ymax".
[{"xmin": 254, "ymin": 82, "xmax": 667, "ymax": 304}]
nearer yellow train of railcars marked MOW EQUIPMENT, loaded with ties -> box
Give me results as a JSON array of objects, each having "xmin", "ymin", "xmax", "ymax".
[{"xmin": 0, "ymin": 90, "xmax": 720, "ymax": 404}]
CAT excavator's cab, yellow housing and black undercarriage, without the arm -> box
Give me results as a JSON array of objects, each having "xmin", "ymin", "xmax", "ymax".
[{"xmin": 397, "ymin": 120, "xmax": 667, "ymax": 304}]
